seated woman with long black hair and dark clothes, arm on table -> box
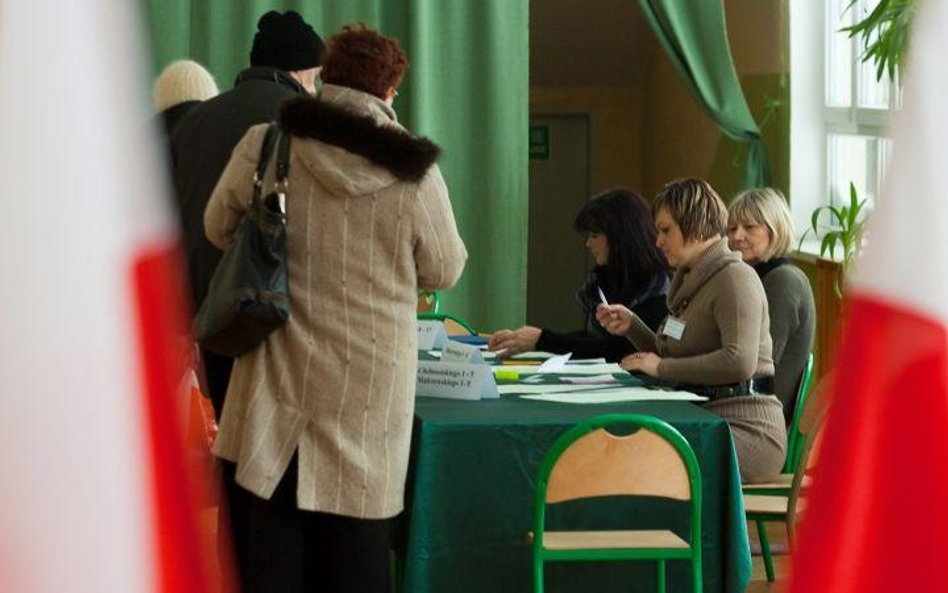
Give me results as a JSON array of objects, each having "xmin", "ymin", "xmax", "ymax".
[{"xmin": 489, "ymin": 188, "xmax": 670, "ymax": 362}]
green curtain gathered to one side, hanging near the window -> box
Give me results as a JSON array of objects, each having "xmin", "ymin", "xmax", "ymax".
[{"xmin": 639, "ymin": 0, "xmax": 771, "ymax": 188}]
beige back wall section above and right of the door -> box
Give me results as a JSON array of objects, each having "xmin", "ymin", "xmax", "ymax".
[{"xmin": 530, "ymin": 86, "xmax": 645, "ymax": 194}]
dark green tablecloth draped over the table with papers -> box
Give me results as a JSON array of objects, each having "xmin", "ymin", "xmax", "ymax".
[{"xmin": 396, "ymin": 386, "xmax": 751, "ymax": 593}]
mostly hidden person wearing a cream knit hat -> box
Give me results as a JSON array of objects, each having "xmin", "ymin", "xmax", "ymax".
[{"xmin": 152, "ymin": 60, "xmax": 220, "ymax": 138}]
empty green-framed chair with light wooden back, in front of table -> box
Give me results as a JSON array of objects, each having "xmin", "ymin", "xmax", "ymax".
[{"xmin": 528, "ymin": 414, "xmax": 702, "ymax": 593}]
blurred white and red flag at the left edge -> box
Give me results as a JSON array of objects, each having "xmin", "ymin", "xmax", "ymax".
[{"xmin": 0, "ymin": 0, "xmax": 215, "ymax": 593}]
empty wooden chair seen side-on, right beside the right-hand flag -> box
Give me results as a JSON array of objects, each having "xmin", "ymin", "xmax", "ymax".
[{"xmin": 744, "ymin": 410, "xmax": 822, "ymax": 582}]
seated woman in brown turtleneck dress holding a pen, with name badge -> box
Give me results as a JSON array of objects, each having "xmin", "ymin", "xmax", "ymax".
[{"xmin": 596, "ymin": 179, "xmax": 787, "ymax": 482}]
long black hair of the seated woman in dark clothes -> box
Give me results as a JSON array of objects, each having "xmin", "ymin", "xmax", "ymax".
[{"xmin": 573, "ymin": 187, "xmax": 668, "ymax": 303}]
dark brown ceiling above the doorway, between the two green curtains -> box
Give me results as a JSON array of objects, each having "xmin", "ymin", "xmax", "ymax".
[{"xmin": 530, "ymin": 0, "xmax": 656, "ymax": 87}]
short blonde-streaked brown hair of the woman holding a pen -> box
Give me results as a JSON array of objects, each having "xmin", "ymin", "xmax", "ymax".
[{"xmin": 652, "ymin": 179, "xmax": 727, "ymax": 241}]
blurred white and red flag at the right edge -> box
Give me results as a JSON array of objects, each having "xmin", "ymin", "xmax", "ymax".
[{"xmin": 789, "ymin": 0, "xmax": 948, "ymax": 593}]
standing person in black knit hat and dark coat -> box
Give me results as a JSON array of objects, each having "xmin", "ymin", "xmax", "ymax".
[{"xmin": 171, "ymin": 10, "xmax": 325, "ymax": 583}]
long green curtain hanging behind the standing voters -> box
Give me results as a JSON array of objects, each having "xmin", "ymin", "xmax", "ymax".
[{"xmin": 146, "ymin": 0, "xmax": 529, "ymax": 330}]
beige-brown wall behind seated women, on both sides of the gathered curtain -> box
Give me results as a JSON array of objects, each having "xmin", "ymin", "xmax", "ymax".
[{"xmin": 530, "ymin": 0, "xmax": 789, "ymax": 199}]
